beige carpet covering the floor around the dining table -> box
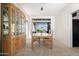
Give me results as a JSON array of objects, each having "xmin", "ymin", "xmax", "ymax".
[{"xmin": 16, "ymin": 40, "xmax": 79, "ymax": 56}]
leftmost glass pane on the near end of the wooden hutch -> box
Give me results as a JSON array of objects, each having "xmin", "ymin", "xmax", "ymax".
[{"xmin": 2, "ymin": 7, "xmax": 9, "ymax": 35}]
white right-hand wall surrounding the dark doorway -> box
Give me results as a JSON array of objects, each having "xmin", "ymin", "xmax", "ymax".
[{"xmin": 56, "ymin": 3, "xmax": 79, "ymax": 47}]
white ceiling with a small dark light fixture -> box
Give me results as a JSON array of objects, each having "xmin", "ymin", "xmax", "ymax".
[{"xmin": 18, "ymin": 3, "xmax": 68, "ymax": 16}]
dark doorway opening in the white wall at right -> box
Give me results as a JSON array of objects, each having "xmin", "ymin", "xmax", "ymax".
[{"xmin": 72, "ymin": 10, "xmax": 79, "ymax": 47}]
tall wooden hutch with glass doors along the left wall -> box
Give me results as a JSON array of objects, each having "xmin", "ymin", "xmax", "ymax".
[{"xmin": 1, "ymin": 3, "xmax": 26, "ymax": 55}]
